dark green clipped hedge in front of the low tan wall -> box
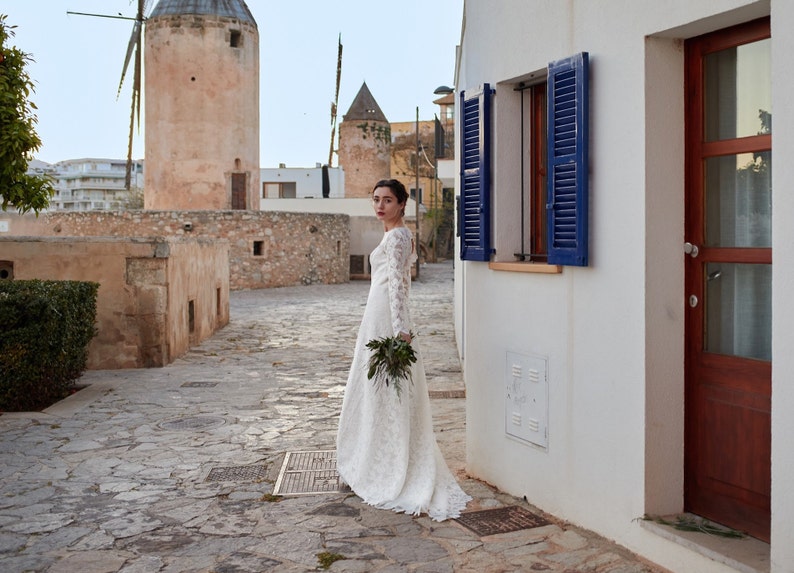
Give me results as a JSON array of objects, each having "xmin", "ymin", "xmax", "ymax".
[{"xmin": 0, "ymin": 280, "xmax": 99, "ymax": 412}]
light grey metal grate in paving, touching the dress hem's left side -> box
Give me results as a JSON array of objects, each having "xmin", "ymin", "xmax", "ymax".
[{"xmin": 273, "ymin": 450, "xmax": 350, "ymax": 495}]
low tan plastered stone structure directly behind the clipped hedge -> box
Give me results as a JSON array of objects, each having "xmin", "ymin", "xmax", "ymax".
[{"xmin": 0, "ymin": 237, "xmax": 229, "ymax": 370}]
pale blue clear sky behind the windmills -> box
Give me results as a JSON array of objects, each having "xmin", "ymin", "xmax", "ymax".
[{"xmin": 0, "ymin": 0, "xmax": 464, "ymax": 167}]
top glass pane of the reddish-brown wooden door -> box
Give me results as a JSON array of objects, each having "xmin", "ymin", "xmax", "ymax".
[{"xmin": 703, "ymin": 39, "xmax": 772, "ymax": 141}]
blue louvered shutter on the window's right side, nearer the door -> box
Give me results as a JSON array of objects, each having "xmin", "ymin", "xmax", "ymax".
[{"xmin": 546, "ymin": 52, "xmax": 590, "ymax": 267}]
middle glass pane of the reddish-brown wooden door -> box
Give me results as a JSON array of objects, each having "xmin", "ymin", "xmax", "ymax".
[{"xmin": 705, "ymin": 151, "xmax": 772, "ymax": 248}]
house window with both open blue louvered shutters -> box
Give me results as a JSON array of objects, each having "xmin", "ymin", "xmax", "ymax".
[{"xmin": 458, "ymin": 52, "xmax": 589, "ymax": 266}]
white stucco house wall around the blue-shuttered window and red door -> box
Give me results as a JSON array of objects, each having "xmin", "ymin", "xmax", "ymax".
[{"xmin": 455, "ymin": 0, "xmax": 780, "ymax": 572}]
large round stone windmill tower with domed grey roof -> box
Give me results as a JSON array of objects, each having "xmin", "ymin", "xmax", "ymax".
[{"xmin": 144, "ymin": 0, "xmax": 259, "ymax": 210}]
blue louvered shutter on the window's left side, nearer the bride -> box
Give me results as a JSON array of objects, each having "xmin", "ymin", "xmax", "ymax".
[{"xmin": 458, "ymin": 84, "xmax": 491, "ymax": 261}]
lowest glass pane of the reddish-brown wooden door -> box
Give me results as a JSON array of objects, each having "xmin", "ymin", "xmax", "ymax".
[{"xmin": 704, "ymin": 263, "xmax": 772, "ymax": 360}]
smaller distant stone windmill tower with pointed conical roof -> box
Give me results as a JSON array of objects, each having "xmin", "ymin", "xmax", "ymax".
[{"xmin": 337, "ymin": 82, "xmax": 391, "ymax": 197}]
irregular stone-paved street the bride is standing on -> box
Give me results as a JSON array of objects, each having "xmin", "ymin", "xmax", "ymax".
[{"xmin": 0, "ymin": 263, "xmax": 661, "ymax": 573}]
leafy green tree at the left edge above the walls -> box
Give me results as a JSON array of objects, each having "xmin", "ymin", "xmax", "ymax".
[{"xmin": 0, "ymin": 14, "xmax": 55, "ymax": 215}]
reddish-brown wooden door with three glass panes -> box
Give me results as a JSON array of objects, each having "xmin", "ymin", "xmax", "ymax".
[{"xmin": 684, "ymin": 15, "xmax": 772, "ymax": 541}]
